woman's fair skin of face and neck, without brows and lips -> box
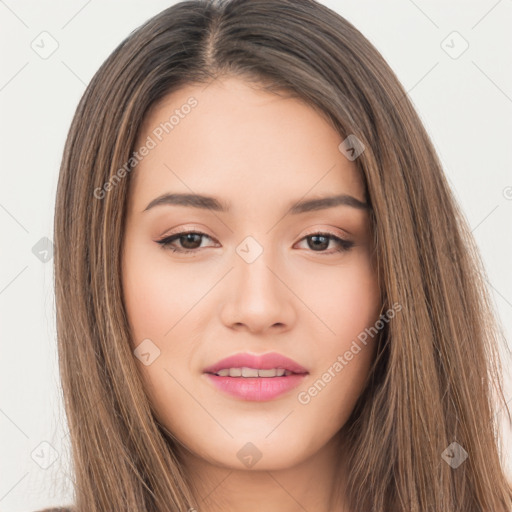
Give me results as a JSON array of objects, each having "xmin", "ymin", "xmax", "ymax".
[{"xmin": 122, "ymin": 77, "xmax": 381, "ymax": 512}]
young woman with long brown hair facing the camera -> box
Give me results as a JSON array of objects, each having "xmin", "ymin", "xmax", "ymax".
[{"xmin": 49, "ymin": 0, "xmax": 512, "ymax": 512}]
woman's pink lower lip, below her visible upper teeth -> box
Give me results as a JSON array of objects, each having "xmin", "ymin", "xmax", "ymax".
[{"xmin": 205, "ymin": 373, "xmax": 307, "ymax": 402}]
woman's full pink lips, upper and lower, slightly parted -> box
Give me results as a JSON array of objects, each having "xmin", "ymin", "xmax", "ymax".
[{"xmin": 203, "ymin": 352, "xmax": 308, "ymax": 402}]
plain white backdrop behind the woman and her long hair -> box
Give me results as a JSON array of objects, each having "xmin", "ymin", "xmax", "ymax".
[{"xmin": 0, "ymin": 0, "xmax": 512, "ymax": 512}]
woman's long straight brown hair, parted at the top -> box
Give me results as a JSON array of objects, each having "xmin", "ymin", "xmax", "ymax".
[{"xmin": 54, "ymin": 0, "xmax": 512, "ymax": 512}]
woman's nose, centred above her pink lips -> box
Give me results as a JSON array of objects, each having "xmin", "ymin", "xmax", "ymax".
[{"xmin": 221, "ymin": 242, "xmax": 297, "ymax": 334}]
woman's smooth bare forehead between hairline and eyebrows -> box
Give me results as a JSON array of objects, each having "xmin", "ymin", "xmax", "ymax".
[{"xmin": 131, "ymin": 78, "xmax": 364, "ymax": 210}]
